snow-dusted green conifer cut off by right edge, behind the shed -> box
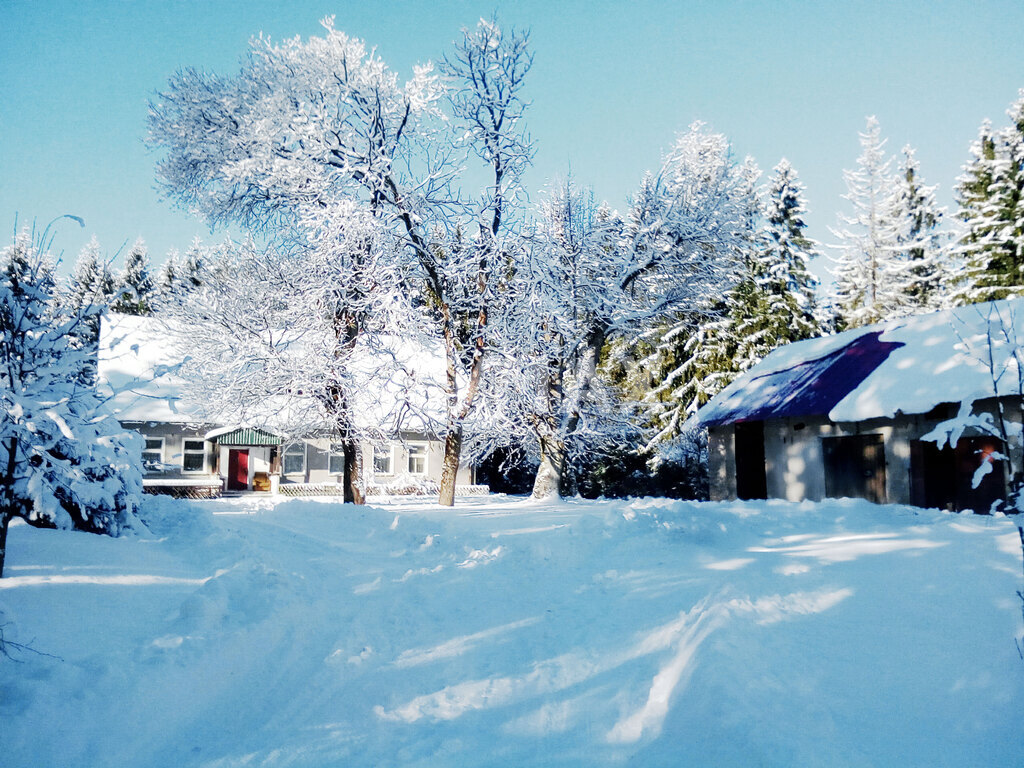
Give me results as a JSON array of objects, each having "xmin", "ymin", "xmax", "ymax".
[{"xmin": 954, "ymin": 95, "xmax": 1024, "ymax": 304}]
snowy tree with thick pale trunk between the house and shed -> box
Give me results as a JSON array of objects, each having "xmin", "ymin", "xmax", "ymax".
[{"xmin": 483, "ymin": 179, "xmax": 629, "ymax": 498}]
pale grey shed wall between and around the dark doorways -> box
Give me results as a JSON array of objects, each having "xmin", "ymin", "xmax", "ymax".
[{"xmin": 708, "ymin": 398, "xmax": 1022, "ymax": 504}]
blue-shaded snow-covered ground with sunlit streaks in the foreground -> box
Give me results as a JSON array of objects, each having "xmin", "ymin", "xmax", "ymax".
[{"xmin": 0, "ymin": 497, "xmax": 1024, "ymax": 768}]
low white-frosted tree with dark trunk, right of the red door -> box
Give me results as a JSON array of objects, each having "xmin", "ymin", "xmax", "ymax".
[{"xmin": 160, "ymin": 202, "xmax": 418, "ymax": 504}]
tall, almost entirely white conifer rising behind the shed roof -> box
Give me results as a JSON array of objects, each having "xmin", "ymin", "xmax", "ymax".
[{"xmin": 833, "ymin": 117, "xmax": 900, "ymax": 330}]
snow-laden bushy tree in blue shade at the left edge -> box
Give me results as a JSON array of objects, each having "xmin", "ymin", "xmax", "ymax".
[{"xmin": 0, "ymin": 232, "xmax": 142, "ymax": 574}]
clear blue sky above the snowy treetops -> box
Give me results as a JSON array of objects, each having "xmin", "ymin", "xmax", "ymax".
[{"xmin": 0, "ymin": 0, "xmax": 1024, "ymax": 276}]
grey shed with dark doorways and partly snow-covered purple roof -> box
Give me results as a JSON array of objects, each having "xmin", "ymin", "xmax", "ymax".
[{"xmin": 696, "ymin": 299, "xmax": 1024, "ymax": 511}]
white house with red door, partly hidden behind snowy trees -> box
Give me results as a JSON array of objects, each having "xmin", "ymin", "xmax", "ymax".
[{"xmin": 98, "ymin": 314, "xmax": 485, "ymax": 494}]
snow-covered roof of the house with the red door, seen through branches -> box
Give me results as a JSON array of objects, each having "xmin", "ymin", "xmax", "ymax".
[{"xmin": 97, "ymin": 314, "xmax": 444, "ymax": 433}]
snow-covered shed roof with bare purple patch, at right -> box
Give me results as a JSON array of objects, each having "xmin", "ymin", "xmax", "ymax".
[{"xmin": 697, "ymin": 299, "xmax": 1024, "ymax": 426}]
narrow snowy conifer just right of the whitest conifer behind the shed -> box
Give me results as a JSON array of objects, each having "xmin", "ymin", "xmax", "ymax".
[{"xmin": 893, "ymin": 146, "xmax": 947, "ymax": 314}]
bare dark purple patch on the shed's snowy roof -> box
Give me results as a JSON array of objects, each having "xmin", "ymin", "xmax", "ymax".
[{"xmin": 700, "ymin": 331, "xmax": 903, "ymax": 427}]
